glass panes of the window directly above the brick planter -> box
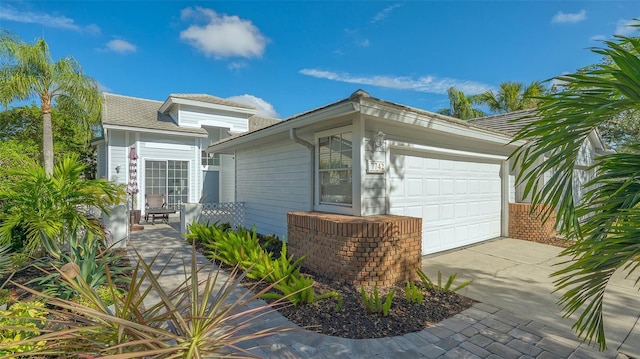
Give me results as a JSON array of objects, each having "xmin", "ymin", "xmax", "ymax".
[{"xmin": 318, "ymin": 132, "xmax": 353, "ymax": 205}]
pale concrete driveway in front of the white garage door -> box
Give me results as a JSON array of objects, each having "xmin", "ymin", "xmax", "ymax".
[{"xmin": 422, "ymin": 238, "xmax": 640, "ymax": 357}]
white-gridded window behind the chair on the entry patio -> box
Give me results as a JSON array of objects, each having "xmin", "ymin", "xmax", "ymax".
[{"xmin": 145, "ymin": 161, "xmax": 189, "ymax": 209}]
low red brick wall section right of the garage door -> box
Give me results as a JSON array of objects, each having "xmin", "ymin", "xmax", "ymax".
[{"xmin": 509, "ymin": 203, "xmax": 556, "ymax": 240}]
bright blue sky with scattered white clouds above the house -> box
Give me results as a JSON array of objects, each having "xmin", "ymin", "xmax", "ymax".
[{"xmin": 0, "ymin": 0, "xmax": 640, "ymax": 118}]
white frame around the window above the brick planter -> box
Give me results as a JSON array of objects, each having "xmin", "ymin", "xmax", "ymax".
[{"xmin": 314, "ymin": 126, "xmax": 360, "ymax": 215}]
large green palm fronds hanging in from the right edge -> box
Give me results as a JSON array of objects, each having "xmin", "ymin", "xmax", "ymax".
[{"xmin": 512, "ymin": 23, "xmax": 640, "ymax": 349}]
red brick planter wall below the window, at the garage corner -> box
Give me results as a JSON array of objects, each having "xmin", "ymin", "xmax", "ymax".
[{"xmin": 287, "ymin": 212, "xmax": 422, "ymax": 287}]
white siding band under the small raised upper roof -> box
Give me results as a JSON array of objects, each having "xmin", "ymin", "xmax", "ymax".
[{"xmin": 179, "ymin": 105, "xmax": 249, "ymax": 132}]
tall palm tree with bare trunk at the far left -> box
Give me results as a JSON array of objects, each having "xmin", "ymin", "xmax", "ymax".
[{"xmin": 0, "ymin": 32, "xmax": 101, "ymax": 175}]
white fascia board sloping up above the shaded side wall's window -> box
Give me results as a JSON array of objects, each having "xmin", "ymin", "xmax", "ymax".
[{"xmin": 205, "ymin": 101, "xmax": 357, "ymax": 153}]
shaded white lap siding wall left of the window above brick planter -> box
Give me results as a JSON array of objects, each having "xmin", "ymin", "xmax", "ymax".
[{"xmin": 236, "ymin": 142, "xmax": 312, "ymax": 239}]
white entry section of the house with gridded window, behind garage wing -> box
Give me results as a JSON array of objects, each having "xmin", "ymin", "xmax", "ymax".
[{"xmin": 92, "ymin": 93, "xmax": 278, "ymax": 213}]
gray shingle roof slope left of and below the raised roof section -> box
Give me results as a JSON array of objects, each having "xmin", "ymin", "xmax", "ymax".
[{"xmin": 102, "ymin": 93, "xmax": 208, "ymax": 135}]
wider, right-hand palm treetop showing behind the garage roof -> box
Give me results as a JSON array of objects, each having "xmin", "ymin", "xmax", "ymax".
[{"xmin": 480, "ymin": 82, "xmax": 544, "ymax": 113}]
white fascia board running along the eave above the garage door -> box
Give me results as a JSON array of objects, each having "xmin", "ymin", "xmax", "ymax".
[{"xmin": 361, "ymin": 103, "xmax": 527, "ymax": 146}]
